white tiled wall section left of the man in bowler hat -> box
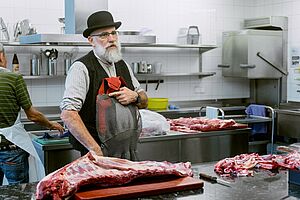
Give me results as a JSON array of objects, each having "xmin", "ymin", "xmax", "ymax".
[{"xmin": 0, "ymin": 0, "xmax": 64, "ymax": 106}]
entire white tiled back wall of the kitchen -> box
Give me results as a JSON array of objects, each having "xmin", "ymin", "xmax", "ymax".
[{"xmin": 0, "ymin": 0, "xmax": 292, "ymax": 106}]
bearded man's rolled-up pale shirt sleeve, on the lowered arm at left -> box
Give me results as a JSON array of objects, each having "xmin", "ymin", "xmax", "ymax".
[{"xmin": 60, "ymin": 61, "xmax": 90, "ymax": 111}]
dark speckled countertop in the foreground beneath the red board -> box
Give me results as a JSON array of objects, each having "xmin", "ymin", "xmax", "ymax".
[{"xmin": 0, "ymin": 162, "xmax": 300, "ymax": 200}]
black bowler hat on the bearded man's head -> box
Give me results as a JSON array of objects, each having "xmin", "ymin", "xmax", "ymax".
[{"xmin": 83, "ymin": 11, "xmax": 122, "ymax": 38}]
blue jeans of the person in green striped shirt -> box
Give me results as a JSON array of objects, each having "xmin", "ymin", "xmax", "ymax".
[{"xmin": 0, "ymin": 149, "xmax": 29, "ymax": 185}]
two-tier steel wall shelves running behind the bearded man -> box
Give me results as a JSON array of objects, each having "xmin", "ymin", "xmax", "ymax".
[{"xmin": 3, "ymin": 40, "xmax": 217, "ymax": 83}]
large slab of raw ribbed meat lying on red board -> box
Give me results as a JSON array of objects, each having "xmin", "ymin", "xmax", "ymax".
[{"xmin": 35, "ymin": 153, "xmax": 193, "ymax": 200}]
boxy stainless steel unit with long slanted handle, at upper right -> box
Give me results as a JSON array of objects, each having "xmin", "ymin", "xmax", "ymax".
[{"xmin": 219, "ymin": 29, "xmax": 285, "ymax": 79}]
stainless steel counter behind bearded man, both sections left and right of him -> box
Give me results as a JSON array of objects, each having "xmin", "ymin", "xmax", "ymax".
[{"xmin": 33, "ymin": 128, "xmax": 251, "ymax": 174}]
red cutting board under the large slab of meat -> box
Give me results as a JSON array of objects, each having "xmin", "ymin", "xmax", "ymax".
[{"xmin": 75, "ymin": 177, "xmax": 203, "ymax": 200}]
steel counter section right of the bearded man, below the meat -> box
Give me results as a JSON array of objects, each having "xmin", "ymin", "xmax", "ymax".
[{"xmin": 138, "ymin": 128, "xmax": 251, "ymax": 163}]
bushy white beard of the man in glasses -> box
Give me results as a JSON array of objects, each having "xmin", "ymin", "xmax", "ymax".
[{"xmin": 94, "ymin": 42, "xmax": 122, "ymax": 63}]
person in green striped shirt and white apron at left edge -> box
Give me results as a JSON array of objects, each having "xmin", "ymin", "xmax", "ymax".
[{"xmin": 0, "ymin": 43, "xmax": 64, "ymax": 185}]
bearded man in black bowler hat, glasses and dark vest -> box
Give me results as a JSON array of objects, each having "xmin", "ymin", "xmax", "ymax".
[{"xmin": 60, "ymin": 11, "xmax": 148, "ymax": 160}]
